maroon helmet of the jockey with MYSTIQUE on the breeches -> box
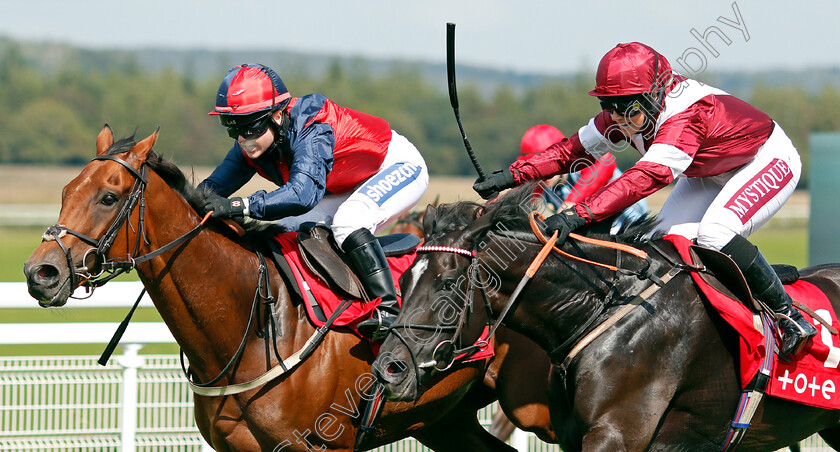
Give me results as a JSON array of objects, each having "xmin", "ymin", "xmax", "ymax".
[{"xmin": 589, "ymin": 42, "xmax": 671, "ymax": 97}]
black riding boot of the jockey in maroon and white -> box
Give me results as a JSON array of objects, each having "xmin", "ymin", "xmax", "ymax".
[{"xmin": 721, "ymin": 235, "xmax": 817, "ymax": 358}]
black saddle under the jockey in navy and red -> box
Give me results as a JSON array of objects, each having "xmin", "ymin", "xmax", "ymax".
[{"xmin": 297, "ymin": 226, "xmax": 420, "ymax": 301}]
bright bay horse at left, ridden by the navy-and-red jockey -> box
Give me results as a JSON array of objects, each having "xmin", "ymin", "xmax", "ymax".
[{"xmin": 24, "ymin": 124, "xmax": 528, "ymax": 451}]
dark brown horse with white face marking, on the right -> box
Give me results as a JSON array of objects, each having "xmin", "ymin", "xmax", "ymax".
[{"xmin": 373, "ymin": 185, "xmax": 840, "ymax": 451}]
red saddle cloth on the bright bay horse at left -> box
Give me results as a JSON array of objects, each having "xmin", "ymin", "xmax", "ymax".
[{"xmin": 274, "ymin": 232, "xmax": 495, "ymax": 362}]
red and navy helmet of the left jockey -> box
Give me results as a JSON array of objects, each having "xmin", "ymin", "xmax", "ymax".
[{"xmin": 207, "ymin": 64, "xmax": 291, "ymax": 116}]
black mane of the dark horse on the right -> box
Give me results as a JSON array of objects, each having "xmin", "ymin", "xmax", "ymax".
[{"xmin": 435, "ymin": 183, "xmax": 661, "ymax": 244}]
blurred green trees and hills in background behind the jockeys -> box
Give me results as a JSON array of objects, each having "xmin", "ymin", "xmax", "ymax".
[{"xmin": 0, "ymin": 34, "xmax": 840, "ymax": 185}]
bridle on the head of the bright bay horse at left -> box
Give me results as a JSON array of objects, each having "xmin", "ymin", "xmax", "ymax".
[{"xmin": 42, "ymin": 155, "xmax": 208, "ymax": 298}]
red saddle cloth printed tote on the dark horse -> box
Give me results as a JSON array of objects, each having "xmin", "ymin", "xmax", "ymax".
[{"xmin": 665, "ymin": 234, "xmax": 840, "ymax": 409}]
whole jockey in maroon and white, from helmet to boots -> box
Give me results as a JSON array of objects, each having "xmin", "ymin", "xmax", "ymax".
[{"xmin": 473, "ymin": 42, "xmax": 816, "ymax": 355}]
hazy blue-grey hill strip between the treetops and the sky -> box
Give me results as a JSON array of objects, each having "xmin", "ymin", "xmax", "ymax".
[{"xmin": 6, "ymin": 37, "xmax": 840, "ymax": 97}]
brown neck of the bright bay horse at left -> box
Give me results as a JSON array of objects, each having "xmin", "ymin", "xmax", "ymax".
[{"xmin": 134, "ymin": 175, "xmax": 311, "ymax": 377}]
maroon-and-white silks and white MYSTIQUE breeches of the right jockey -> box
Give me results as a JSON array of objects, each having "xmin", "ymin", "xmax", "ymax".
[{"xmin": 510, "ymin": 79, "xmax": 802, "ymax": 250}]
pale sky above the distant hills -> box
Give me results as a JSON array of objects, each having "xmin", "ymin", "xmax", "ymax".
[{"xmin": 0, "ymin": 0, "xmax": 840, "ymax": 75}]
